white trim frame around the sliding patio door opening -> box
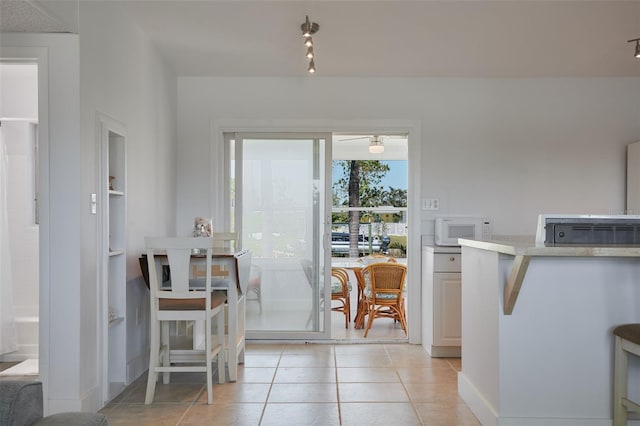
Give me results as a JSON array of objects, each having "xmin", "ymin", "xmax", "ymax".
[{"xmin": 215, "ymin": 119, "xmax": 422, "ymax": 344}]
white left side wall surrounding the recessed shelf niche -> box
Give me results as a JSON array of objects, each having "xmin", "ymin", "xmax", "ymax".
[{"xmin": 79, "ymin": 2, "xmax": 177, "ymax": 410}]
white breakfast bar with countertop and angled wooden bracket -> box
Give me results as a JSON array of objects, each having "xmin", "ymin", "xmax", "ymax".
[{"xmin": 458, "ymin": 237, "xmax": 640, "ymax": 426}]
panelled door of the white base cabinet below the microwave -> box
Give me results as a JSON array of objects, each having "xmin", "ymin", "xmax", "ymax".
[{"xmin": 433, "ymin": 273, "xmax": 462, "ymax": 346}]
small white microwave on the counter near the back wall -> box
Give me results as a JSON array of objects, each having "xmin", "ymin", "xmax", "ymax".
[{"xmin": 435, "ymin": 216, "xmax": 491, "ymax": 246}]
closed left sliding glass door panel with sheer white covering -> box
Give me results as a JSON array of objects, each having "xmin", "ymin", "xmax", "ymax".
[{"xmin": 225, "ymin": 133, "xmax": 331, "ymax": 339}]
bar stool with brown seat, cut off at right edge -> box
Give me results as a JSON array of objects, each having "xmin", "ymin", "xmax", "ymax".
[{"xmin": 613, "ymin": 324, "xmax": 640, "ymax": 426}]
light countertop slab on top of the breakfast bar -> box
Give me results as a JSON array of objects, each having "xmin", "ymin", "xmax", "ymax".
[{"xmin": 459, "ymin": 236, "xmax": 640, "ymax": 257}]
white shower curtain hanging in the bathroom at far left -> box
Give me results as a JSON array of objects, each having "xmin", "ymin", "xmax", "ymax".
[{"xmin": 0, "ymin": 123, "xmax": 18, "ymax": 355}]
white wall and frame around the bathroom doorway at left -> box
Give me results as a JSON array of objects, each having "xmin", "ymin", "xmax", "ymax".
[{"xmin": 0, "ymin": 33, "xmax": 83, "ymax": 415}]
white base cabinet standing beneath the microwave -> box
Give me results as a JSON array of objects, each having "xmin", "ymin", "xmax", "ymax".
[{"xmin": 422, "ymin": 247, "xmax": 462, "ymax": 357}]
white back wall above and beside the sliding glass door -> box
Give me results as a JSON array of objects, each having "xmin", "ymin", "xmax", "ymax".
[{"xmin": 177, "ymin": 76, "xmax": 640, "ymax": 235}]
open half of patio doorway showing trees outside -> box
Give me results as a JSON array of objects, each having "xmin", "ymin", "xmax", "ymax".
[{"xmin": 331, "ymin": 133, "xmax": 410, "ymax": 342}]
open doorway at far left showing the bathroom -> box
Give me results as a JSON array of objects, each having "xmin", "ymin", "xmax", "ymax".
[{"xmin": 0, "ymin": 60, "xmax": 40, "ymax": 376}]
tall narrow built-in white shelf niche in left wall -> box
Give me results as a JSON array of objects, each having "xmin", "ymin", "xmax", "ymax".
[{"xmin": 98, "ymin": 116, "xmax": 129, "ymax": 403}]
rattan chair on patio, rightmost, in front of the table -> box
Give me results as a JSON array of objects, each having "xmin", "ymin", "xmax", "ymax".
[{"xmin": 362, "ymin": 262, "xmax": 407, "ymax": 337}]
